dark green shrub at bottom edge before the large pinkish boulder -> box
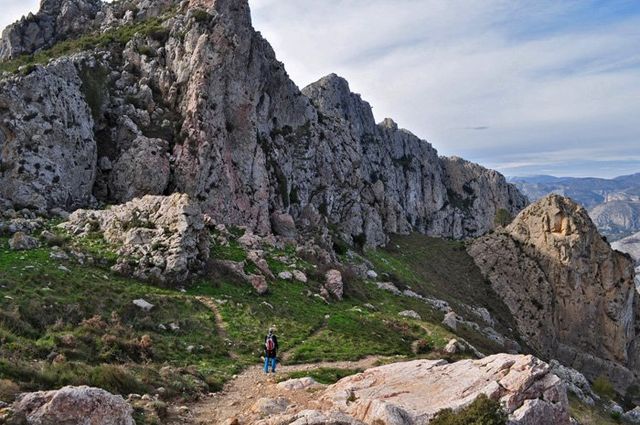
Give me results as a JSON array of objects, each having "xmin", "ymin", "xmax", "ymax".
[{"xmin": 429, "ymin": 394, "xmax": 507, "ymax": 425}]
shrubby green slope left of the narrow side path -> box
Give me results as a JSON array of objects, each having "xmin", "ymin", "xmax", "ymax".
[{"xmin": 0, "ymin": 234, "xmax": 238, "ymax": 399}]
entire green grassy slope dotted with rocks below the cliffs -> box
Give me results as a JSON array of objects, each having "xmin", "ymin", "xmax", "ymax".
[{"xmin": 0, "ymin": 224, "xmax": 478, "ymax": 400}]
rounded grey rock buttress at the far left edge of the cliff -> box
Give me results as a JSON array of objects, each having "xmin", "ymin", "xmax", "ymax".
[{"xmin": 0, "ymin": 60, "xmax": 97, "ymax": 212}]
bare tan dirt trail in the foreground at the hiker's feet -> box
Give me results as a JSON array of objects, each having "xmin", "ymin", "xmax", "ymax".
[{"xmin": 168, "ymin": 357, "xmax": 380, "ymax": 425}]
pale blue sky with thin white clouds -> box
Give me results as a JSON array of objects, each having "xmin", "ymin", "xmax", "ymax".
[{"xmin": 0, "ymin": 0, "xmax": 640, "ymax": 177}]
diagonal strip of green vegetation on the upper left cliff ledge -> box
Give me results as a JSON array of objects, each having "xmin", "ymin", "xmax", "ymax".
[{"xmin": 0, "ymin": 12, "xmax": 174, "ymax": 74}]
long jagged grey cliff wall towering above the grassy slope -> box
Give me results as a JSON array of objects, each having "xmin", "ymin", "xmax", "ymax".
[{"xmin": 0, "ymin": 0, "xmax": 526, "ymax": 246}]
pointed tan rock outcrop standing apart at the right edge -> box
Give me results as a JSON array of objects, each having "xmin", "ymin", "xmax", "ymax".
[{"xmin": 469, "ymin": 195, "xmax": 638, "ymax": 392}]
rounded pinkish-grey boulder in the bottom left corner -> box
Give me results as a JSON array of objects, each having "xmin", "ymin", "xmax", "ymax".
[{"xmin": 13, "ymin": 386, "xmax": 135, "ymax": 425}]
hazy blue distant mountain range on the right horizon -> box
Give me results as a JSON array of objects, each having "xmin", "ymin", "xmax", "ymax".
[{"xmin": 509, "ymin": 173, "xmax": 640, "ymax": 241}]
